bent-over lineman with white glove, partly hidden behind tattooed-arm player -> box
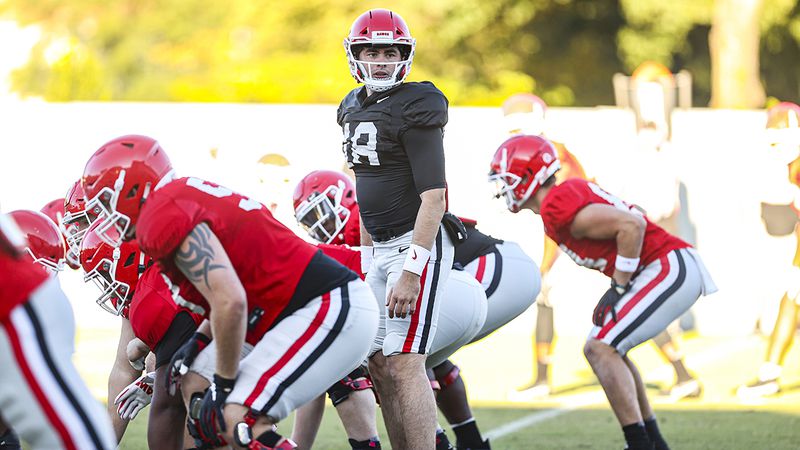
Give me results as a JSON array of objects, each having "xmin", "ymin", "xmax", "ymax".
[{"xmin": 80, "ymin": 221, "xmax": 203, "ymax": 449}]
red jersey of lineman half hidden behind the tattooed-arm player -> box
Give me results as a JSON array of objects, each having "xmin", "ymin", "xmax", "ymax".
[{"xmin": 128, "ymin": 265, "xmax": 204, "ymax": 350}]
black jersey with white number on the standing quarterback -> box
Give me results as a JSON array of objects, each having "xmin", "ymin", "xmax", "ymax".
[{"xmin": 337, "ymin": 82, "xmax": 448, "ymax": 236}]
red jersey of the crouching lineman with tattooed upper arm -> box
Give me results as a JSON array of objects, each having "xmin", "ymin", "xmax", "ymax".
[{"xmin": 136, "ymin": 178, "xmax": 317, "ymax": 343}]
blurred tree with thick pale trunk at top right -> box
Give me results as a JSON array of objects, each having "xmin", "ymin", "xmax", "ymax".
[{"xmin": 618, "ymin": 0, "xmax": 800, "ymax": 108}]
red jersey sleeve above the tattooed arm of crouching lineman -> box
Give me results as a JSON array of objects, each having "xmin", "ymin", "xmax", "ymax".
[{"xmin": 136, "ymin": 196, "xmax": 197, "ymax": 260}]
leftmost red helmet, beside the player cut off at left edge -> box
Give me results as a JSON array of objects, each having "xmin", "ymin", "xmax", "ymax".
[{"xmin": 8, "ymin": 209, "xmax": 65, "ymax": 274}]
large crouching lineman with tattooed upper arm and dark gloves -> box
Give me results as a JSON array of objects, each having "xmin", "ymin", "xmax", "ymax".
[{"xmin": 82, "ymin": 136, "xmax": 378, "ymax": 449}]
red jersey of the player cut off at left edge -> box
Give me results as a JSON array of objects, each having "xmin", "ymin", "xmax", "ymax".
[{"xmin": 0, "ymin": 251, "xmax": 48, "ymax": 320}]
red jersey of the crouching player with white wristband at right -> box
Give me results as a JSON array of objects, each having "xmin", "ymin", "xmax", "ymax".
[{"xmin": 540, "ymin": 178, "xmax": 690, "ymax": 277}]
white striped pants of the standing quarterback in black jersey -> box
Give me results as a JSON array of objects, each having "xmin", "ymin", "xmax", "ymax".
[{"xmin": 367, "ymin": 225, "xmax": 454, "ymax": 356}]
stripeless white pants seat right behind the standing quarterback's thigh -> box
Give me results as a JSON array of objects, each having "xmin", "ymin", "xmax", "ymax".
[{"xmin": 425, "ymin": 270, "xmax": 487, "ymax": 369}]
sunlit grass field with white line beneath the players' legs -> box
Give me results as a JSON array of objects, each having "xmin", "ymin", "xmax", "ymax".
[{"xmin": 111, "ymin": 334, "xmax": 800, "ymax": 450}]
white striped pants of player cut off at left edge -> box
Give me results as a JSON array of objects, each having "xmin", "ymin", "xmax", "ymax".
[{"xmin": 0, "ymin": 278, "xmax": 116, "ymax": 450}]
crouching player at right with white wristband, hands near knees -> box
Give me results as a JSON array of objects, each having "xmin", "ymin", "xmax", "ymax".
[{"xmin": 489, "ymin": 135, "xmax": 716, "ymax": 450}]
